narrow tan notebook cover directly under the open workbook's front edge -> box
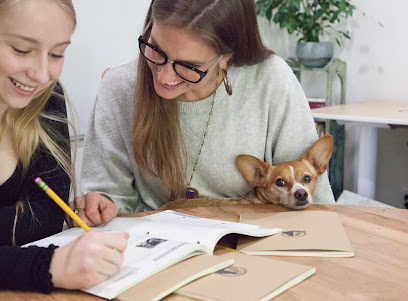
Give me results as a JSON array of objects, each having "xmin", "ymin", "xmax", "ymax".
[{"xmin": 116, "ymin": 255, "xmax": 234, "ymax": 301}]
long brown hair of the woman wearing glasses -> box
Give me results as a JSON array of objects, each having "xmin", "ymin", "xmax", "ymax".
[{"xmin": 133, "ymin": 0, "xmax": 273, "ymax": 199}]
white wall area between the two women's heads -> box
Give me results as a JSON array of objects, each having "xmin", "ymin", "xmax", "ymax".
[{"xmin": 61, "ymin": 0, "xmax": 150, "ymax": 134}]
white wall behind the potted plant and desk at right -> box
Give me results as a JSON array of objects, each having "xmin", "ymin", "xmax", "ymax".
[{"xmin": 259, "ymin": 0, "xmax": 408, "ymax": 207}]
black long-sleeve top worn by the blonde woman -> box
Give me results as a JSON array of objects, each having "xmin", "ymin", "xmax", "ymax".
[{"xmin": 0, "ymin": 84, "xmax": 70, "ymax": 292}]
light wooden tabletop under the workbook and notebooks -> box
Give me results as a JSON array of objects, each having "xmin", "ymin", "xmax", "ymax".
[{"xmin": 0, "ymin": 204, "xmax": 408, "ymax": 301}]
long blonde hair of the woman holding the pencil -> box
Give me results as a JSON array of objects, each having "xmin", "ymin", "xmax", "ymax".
[{"xmin": 0, "ymin": 0, "xmax": 76, "ymax": 244}]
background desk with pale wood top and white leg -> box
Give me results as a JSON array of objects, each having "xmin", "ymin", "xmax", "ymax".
[{"xmin": 312, "ymin": 101, "xmax": 408, "ymax": 199}]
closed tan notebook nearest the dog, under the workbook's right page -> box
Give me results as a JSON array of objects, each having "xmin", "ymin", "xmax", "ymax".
[{"xmin": 237, "ymin": 211, "xmax": 354, "ymax": 257}]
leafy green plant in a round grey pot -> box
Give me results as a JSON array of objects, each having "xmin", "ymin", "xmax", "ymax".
[{"xmin": 256, "ymin": 0, "xmax": 356, "ymax": 68}]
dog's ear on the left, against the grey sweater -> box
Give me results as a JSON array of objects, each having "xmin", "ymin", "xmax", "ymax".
[{"xmin": 235, "ymin": 155, "xmax": 270, "ymax": 187}]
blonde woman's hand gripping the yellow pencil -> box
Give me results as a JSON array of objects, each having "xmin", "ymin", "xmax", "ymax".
[{"xmin": 50, "ymin": 232, "xmax": 129, "ymax": 289}]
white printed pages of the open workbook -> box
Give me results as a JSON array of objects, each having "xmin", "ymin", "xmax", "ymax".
[{"xmin": 26, "ymin": 210, "xmax": 281, "ymax": 299}]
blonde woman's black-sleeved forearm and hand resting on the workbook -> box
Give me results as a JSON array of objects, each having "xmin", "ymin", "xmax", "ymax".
[{"xmin": 0, "ymin": 232, "xmax": 129, "ymax": 293}]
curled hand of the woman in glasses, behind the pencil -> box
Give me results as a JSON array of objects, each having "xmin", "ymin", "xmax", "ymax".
[{"xmin": 66, "ymin": 192, "xmax": 118, "ymax": 228}]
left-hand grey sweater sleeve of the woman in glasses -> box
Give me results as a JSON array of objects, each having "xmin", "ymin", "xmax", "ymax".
[{"xmin": 81, "ymin": 68, "xmax": 140, "ymax": 214}]
